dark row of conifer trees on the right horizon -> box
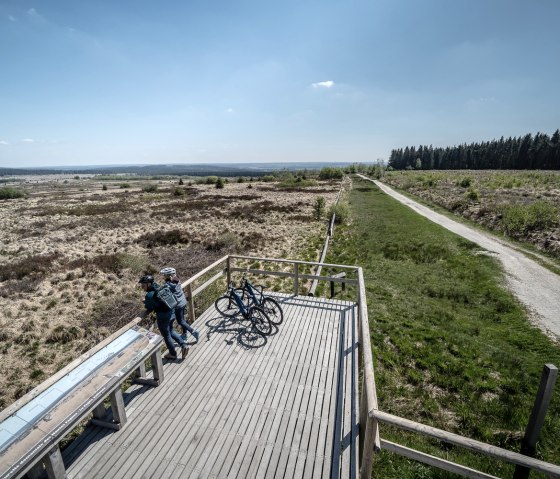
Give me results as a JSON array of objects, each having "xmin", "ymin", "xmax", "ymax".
[{"xmin": 389, "ymin": 130, "xmax": 560, "ymax": 170}]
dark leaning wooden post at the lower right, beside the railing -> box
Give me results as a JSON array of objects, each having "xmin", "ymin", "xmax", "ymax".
[{"xmin": 513, "ymin": 364, "xmax": 558, "ymax": 479}]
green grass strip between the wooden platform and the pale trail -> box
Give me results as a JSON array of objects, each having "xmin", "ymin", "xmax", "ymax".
[{"xmin": 326, "ymin": 180, "xmax": 560, "ymax": 478}]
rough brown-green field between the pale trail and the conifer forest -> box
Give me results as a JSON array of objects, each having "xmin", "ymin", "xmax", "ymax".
[{"xmin": 383, "ymin": 170, "xmax": 560, "ymax": 257}]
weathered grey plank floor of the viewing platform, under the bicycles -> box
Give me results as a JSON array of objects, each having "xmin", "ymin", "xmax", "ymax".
[{"xmin": 63, "ymin": 295, "xmax": 359, "ymax": 479}]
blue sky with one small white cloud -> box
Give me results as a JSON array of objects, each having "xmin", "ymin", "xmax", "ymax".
[{"xmin": 0, "ymin": 0, "xmax": 560, "ymax": 167}]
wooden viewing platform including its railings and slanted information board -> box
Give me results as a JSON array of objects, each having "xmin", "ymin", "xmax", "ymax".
[{"xmin": 0, "ymin": 255, "xmax": 560, "ymax": 479}]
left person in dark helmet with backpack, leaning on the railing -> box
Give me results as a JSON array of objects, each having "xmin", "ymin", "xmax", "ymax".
[{"xmin": 138, "ymin": 274, "xmax": 189, "ymax": 359}]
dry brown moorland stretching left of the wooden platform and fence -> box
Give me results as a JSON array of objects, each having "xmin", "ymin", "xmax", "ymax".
[{"xmin": 0, "ymin": 176, "xmax": 339, "ymax": 408}]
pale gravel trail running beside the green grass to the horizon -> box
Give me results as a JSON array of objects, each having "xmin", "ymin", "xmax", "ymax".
[{"xmin": 359, "ymin": 175, "xmax": 560, "ymax": 338}]
